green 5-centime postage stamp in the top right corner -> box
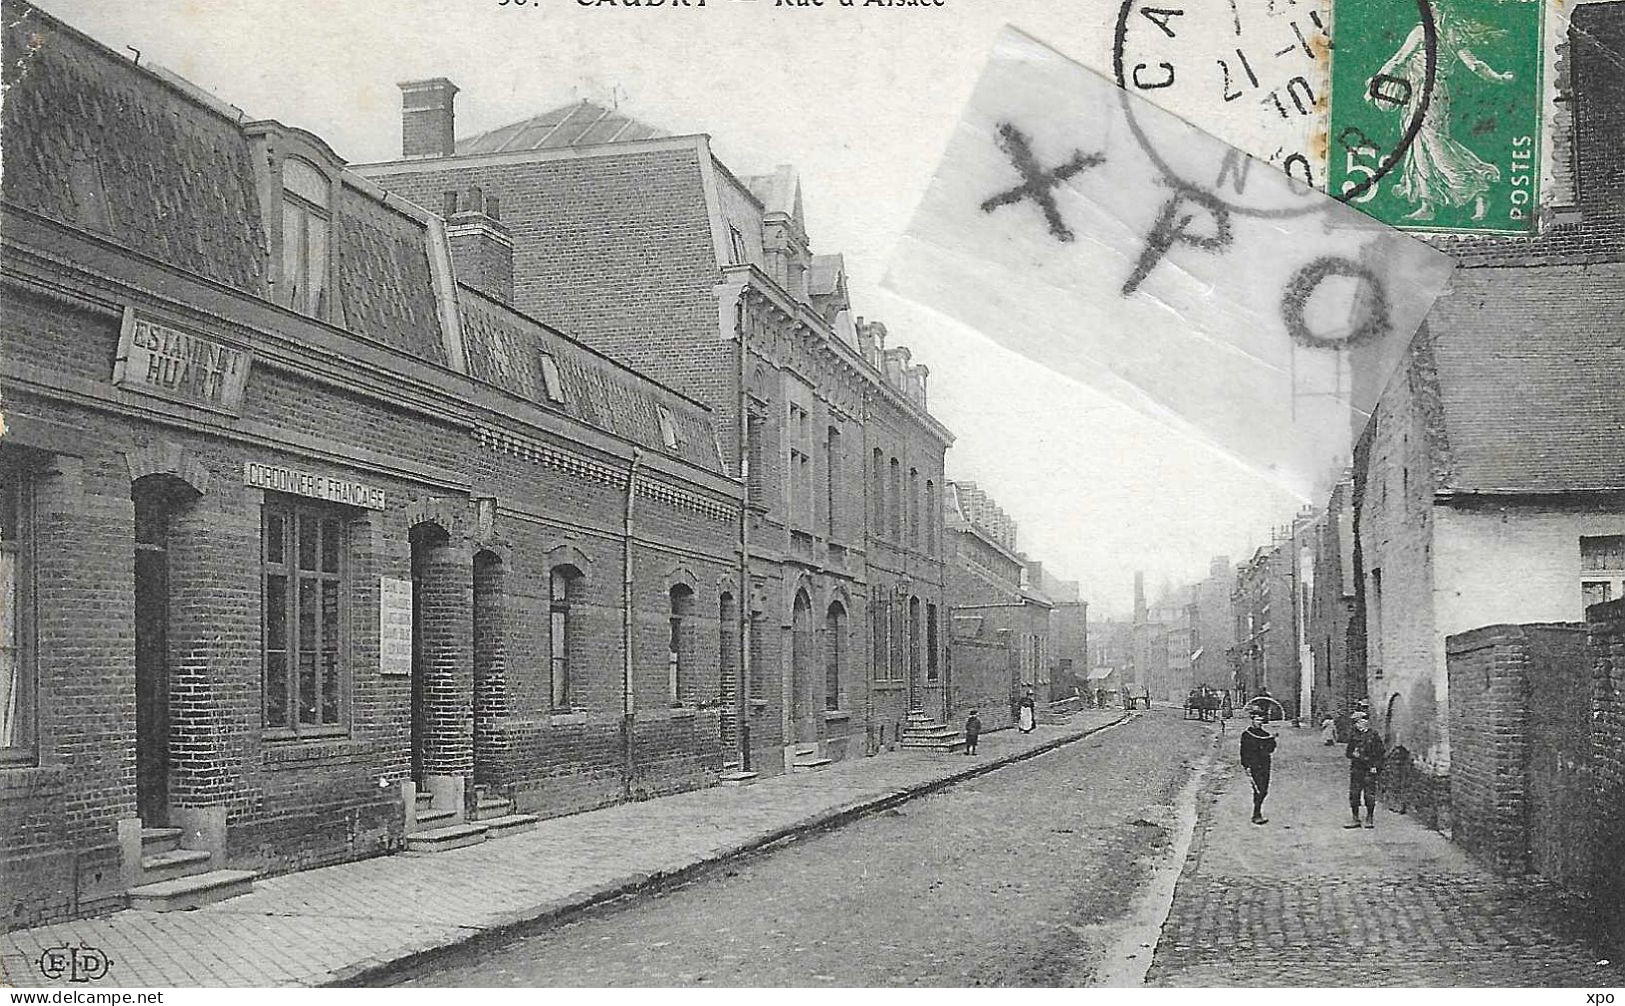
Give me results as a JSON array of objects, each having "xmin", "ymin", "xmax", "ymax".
[{"xmin": 1326, "ymin": 0, "xmax": 1545, "ymax": 234}]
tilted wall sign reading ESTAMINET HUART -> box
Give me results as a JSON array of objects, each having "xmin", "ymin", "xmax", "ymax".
[{"xmin": 112, "ymin": 307, "xmax": 254, "ymax": 416}]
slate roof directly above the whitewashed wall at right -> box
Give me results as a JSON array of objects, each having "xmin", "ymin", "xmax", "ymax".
[{"xmin": 1428, "ymin": 263, "xmax": 1625, "ymax": 492}]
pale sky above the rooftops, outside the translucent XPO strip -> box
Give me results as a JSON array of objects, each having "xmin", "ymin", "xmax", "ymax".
[{"xmin": 37, "ymin": 0, "xmax": 1300, "ymax": 616}]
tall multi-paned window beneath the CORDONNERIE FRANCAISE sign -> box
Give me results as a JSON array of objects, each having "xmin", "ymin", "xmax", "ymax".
[{"xmin": 262, "ymin": 502, "xmax": 348, "ymax": 736}]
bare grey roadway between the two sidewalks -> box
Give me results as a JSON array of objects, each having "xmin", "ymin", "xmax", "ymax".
[{"xmin": 383, "ymin": 710, "xmax": 1212, "ymax": 986}]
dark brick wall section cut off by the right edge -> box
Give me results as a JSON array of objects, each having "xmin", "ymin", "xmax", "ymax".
[{"xmin": 1586, "ymin": 600, "xmax": 1625, "ymax": 954}]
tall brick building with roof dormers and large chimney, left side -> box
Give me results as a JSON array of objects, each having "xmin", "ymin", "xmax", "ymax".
[{"xmin": 358, "ymin": 92, "xmax": 952, "ymax": 770}]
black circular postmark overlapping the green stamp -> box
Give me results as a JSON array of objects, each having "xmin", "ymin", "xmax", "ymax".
[{"xmin": 1112, "ymin": 0, "xmax": 1438, "ymax": 218}]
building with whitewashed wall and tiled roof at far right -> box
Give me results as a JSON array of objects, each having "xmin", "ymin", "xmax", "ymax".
[{"xmin": 1354, "ymin": 2, "xmax": 1625, "ymax": 826}]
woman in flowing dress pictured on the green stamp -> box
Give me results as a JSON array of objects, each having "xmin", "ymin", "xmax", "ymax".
[{"xmin": 1365, "ymin": 0, "xmax": 1513, "ymax": 219}]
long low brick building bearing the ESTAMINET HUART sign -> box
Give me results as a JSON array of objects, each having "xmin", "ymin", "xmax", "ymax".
[{"xmin": 0, "ymin": 0, "xmax": 743, "ymax": 926}]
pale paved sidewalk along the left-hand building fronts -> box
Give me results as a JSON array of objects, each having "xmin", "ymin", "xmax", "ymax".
[{"xmin": 0, "ymin": 710, "xmax": 1121, "ymax": 988}]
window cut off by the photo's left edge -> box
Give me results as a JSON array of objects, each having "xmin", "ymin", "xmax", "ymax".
[{"xmin": 0, "ymin": 462, "xmax": 36, "ymax": 764}]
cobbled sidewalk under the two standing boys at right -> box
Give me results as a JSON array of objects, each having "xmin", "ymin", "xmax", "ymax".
[{"xmin": 1146, "ymin": 726, "xmax": 1625, "ymax": 988}]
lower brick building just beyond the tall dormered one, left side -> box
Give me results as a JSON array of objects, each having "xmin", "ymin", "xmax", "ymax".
[{"xmin": 944, "ymin": 481, "xmax": 1053, "ymax": 728}]
